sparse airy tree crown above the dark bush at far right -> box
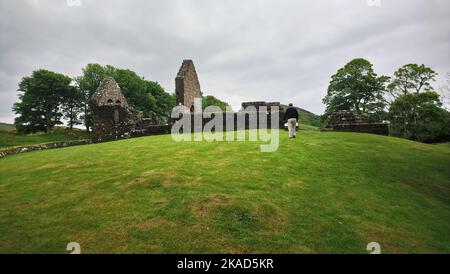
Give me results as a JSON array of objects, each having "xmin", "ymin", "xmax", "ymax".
[{"xmin": 388, "ymin": 64, "xmax": 437, "ymax": 98}]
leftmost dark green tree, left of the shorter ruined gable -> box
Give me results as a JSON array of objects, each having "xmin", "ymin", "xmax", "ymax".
[{"xmin": 13, "ymin": 69, "xmax": 72, "ymax": 133}]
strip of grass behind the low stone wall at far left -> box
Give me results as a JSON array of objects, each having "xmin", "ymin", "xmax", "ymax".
[{"xmin": 0, "ymin": 127, "xmax": 89, "ymax": 149}]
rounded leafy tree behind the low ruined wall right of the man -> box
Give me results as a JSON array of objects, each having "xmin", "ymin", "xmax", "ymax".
[{"xmin": 323, "ymin": 58, "xmax": 389, "ymax": 120}]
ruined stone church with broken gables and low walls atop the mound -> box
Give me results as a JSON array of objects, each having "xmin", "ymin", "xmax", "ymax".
[{"xmin": 90, "ymin": 60, "xmax": 388, "ymax": 142}]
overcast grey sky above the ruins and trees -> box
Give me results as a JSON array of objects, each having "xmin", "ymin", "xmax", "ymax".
[{"xmin": 0, "ymin": 0, "xmax": 450, "ymax": 122}]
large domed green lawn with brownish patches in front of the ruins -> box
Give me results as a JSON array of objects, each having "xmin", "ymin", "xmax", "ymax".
[{"xmin": 0, "ymin": 130, "xmax": 450, "ymax": 253}]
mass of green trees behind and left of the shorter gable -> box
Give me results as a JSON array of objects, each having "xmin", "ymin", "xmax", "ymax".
[{"xmin": 13, "ymin": 64, "xmax": 175, "ymax": 132}]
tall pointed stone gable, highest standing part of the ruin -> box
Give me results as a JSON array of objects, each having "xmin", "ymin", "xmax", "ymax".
[{"xmin": 175, "ymin": 60, "xmax": 202, "ymax": 108}]
